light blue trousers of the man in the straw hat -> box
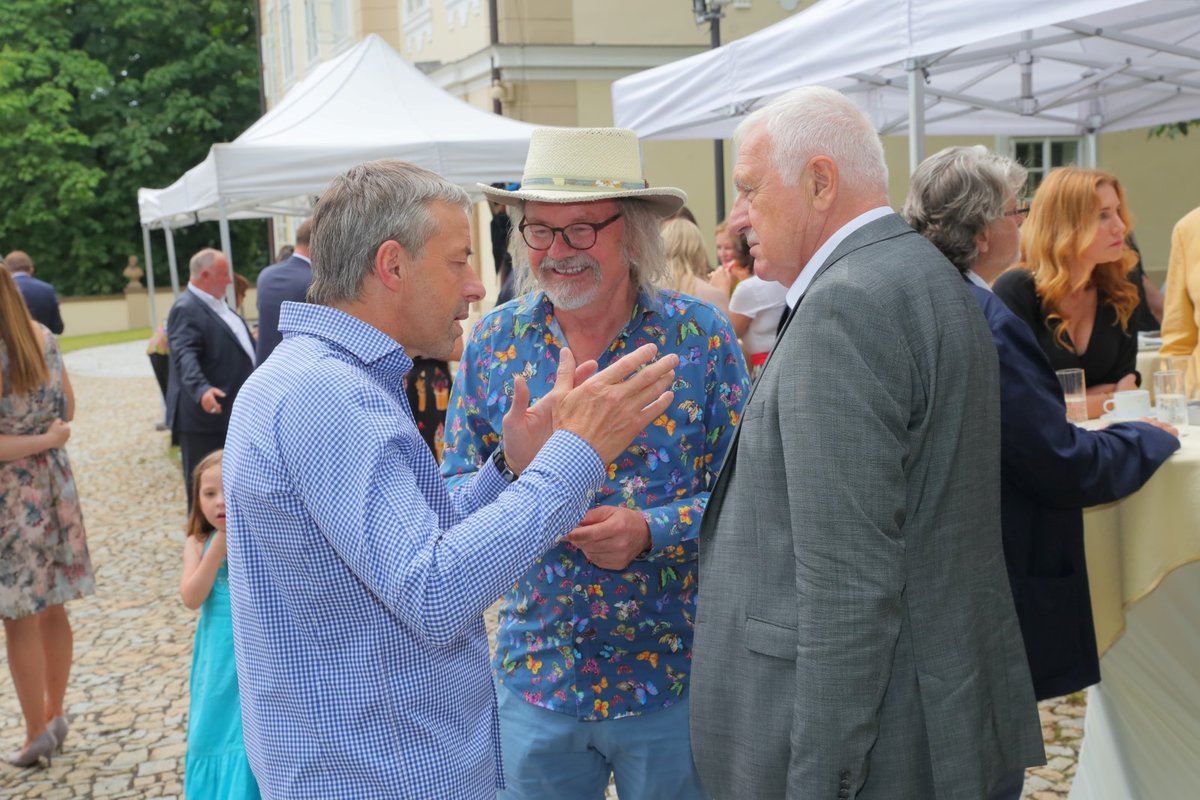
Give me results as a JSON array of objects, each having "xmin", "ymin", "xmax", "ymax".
[{"xmin": 496, "ymin": 685, "xmax": 708, "ymax": 800}]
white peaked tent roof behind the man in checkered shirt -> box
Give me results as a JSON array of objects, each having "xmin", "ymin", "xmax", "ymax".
[{"xmin": 138, "ymin": 34, "xmax": 535, "ymax": 227}]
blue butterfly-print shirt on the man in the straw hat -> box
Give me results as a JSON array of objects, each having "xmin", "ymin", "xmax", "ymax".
[{"xmin": 442, "ymin": 290, "xmax": 749, "ymax": 720}]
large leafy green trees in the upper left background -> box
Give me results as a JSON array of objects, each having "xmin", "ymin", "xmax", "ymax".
[{"xmin": 0, "ymin": 0, "xmax": 268, "ymax": 295}]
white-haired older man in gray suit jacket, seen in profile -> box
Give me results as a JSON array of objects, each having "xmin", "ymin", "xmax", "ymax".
[{"xmin": 691, "ymin": 88, "xmax": 1044, "ymax": 800}]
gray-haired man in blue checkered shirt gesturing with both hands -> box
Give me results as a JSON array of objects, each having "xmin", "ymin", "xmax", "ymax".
[{"xmin": 224, "ymin": 161, "xmax": 678, "ymax": 800}]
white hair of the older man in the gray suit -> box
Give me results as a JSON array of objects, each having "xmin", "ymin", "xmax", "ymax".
[{"xmin": 733, "ymin": 86, "xmax": 888, "ymax": 196}]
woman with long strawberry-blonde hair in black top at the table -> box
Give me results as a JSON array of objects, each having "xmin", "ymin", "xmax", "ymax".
[{"xmin": 994, "ymin": 167, "xmax": 1139, "ymax": 417}]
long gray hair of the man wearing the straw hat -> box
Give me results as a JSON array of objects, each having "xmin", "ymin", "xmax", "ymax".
[{"xmin": 509, "ymin": 199, "xmax": 668, "ymax": 297}]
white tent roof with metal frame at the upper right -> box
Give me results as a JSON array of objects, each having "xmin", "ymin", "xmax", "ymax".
[{"xmin": 613, "ymin": 0, "xmax": 1200, "ymax": 139}]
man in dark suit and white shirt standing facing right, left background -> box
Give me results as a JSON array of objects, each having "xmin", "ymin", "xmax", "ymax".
[{"xmin": 167, "ymin": 248, "xmax": 254, "ymax": 509}]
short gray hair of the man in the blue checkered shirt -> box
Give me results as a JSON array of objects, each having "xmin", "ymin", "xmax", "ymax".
[{"xmin": 308, "ymin": 158, "xmax": 470, "ymax": 306}]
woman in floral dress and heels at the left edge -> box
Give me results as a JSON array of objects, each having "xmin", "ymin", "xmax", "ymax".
[{"xmin": 0, "ymin": 269, "xmax": 94, "ymax": 766}]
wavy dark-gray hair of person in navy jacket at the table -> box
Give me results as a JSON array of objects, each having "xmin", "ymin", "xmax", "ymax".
[{"xmin": 901, "ymin": 145, "xmax": 1026, "ymax": 272}]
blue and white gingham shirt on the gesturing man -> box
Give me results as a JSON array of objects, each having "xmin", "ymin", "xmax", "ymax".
[{"xmin": 223, "ymin": 302, "xmax": 604, "ymax": 800}]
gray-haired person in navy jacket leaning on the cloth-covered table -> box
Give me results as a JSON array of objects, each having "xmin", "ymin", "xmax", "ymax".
[{"xmin": 904, "ymin": 146, "xmax": 1180, "ymax": 710}]
